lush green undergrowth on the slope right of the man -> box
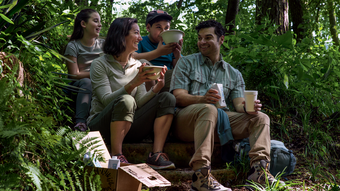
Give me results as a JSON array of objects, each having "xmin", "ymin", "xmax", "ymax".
[{"xmin": 222, "ymin": 17, "xmax": 340, "ymax": 163}]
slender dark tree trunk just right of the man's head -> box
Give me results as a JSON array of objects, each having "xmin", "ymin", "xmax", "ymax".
[{"xmin": 225, "ymin": 0, "xmax": 240, "ymax": 35}]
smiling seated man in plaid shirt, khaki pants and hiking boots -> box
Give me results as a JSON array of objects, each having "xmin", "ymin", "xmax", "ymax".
[{"xmin": 170, "ymin": 20, "xmax": 284, "ymax": 191}]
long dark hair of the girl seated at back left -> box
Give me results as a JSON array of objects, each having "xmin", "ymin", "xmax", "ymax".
[{"xmin": 70, "ymin": 9, "xmax": 97, "ymax": 41}]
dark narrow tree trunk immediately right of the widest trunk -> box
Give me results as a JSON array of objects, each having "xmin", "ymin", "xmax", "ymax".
[{"xmin": 289, "ymin": 0, "xmax": 306, "ymax": 42}]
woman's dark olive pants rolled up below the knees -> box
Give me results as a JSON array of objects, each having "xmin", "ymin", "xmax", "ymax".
[{"xmin": 88, "ymin": 92, "xmax": 176, "ymax": 143}]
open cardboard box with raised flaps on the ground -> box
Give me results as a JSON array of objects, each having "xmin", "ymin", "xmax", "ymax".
[{"xmin": 79, "ymin": 131, "xmax": 171, "ymax": 191}]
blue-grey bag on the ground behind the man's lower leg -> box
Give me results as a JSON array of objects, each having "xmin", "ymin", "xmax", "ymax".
[{"xmin": 230, "ymin": 138, "xmax": 296, "ymax": 176}]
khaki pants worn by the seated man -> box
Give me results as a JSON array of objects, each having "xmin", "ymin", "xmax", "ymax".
[{"xmin": 173, "ymin": 104, "xmax": 270, "ymax": 170}]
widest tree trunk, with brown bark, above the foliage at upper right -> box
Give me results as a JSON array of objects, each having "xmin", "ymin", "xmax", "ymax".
[{"xmin": 256, "ymin": 0, "xmax": 289, "ymax": 35}]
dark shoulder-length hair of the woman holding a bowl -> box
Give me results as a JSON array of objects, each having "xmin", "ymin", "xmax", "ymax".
[{"xmin": 103, "ymin": 18, "xmax": 137, "ymax": 56}]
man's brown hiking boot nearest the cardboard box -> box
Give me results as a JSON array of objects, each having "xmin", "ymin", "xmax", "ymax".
[{"xmin": 190, "ymin": 167, "xmax": 232, "ymax": 191}]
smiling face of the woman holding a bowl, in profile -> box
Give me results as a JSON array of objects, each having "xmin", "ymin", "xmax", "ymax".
[{"xmin": 125, "ymin": 23, "xmax": 143, "ymax": 53}]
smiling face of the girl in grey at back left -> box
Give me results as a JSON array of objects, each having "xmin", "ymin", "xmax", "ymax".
[{"xmin": 81, "ymin": 12, "xmax": 102, "ymax": 38}]
